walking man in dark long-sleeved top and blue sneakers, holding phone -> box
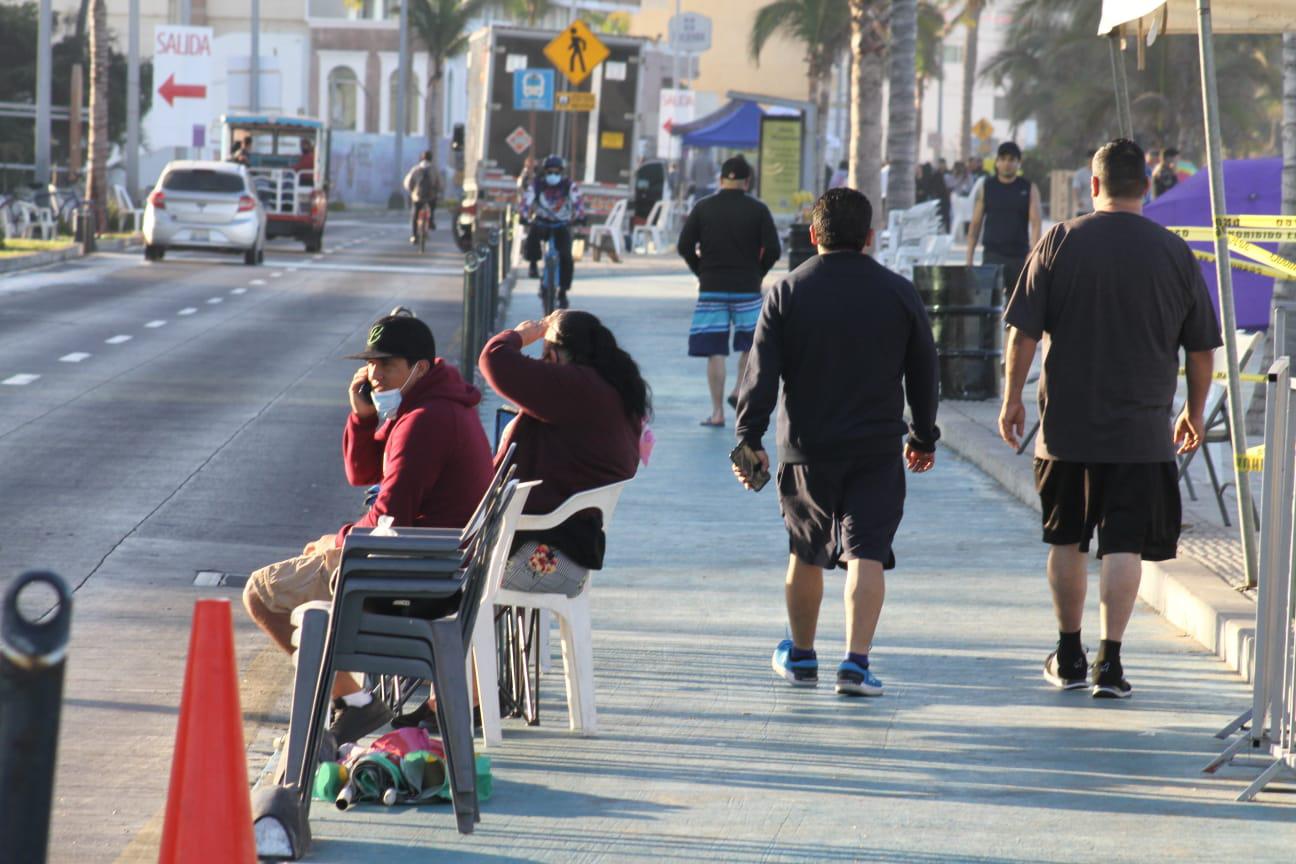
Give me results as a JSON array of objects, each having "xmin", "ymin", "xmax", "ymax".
[{"xmin": 735, "ymin": 188, "xmax": 940, "ymax": 696}]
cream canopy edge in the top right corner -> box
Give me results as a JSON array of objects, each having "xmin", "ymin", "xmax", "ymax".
[{"xmin": 1098, "ymin": 0, "xmax": 1296, "ymax": 39}]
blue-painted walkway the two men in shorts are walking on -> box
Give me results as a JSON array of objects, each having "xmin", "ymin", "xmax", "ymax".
[{"xmin": 286, "ymin": 271, "xmax": 1296, "ymax": 864}]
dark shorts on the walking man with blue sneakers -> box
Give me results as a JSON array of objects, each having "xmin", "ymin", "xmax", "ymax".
[{"xmin": 779, "ymin": 453, "xmax": 905, "ymax": 570}]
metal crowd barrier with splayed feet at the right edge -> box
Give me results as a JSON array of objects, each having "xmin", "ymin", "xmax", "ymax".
[{"xmin": 1204, "ymin": 356, "xmax": 1296, "ymax": 801}]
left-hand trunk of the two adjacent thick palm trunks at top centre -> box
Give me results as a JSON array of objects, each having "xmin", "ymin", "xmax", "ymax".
[{"xmin": 846, "ymin": 0, "xmax": 886, "ymax": 212}]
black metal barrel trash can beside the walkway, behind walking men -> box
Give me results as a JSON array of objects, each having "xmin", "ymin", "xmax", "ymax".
[{"xmin": 914, "ymin": 266, "xmax": 1003, "ymax": 399}]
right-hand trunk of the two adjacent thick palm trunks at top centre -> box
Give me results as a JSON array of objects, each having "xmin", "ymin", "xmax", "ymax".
[{"xmin": 885, "ymin": 0, "xmax": 918, "ymax": 210}]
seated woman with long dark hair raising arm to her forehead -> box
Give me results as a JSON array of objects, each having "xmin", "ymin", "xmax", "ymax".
[{"xmin": 477, "ymin": 310, "xmax": 652, "ymax": 597}]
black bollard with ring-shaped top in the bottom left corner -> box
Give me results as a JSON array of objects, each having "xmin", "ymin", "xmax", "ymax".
[{"xmin": 0, "ymin": 573, "xmax": 73, "ymax": 863}]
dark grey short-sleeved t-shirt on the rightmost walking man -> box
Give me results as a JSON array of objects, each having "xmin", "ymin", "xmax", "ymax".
[{"xmin": 1003, "ymin": 212, "xmax": 1221, "ymax": 462}]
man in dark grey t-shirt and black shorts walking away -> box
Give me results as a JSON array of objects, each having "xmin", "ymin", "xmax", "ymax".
[{"xmin": 999, "ymin": 139, "xmax": 1221, "ymax": 698}]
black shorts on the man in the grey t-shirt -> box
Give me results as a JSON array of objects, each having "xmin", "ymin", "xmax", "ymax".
[{"xmin": 1036, "ymin": 459, "xmax": 1183, "ymax": 561}]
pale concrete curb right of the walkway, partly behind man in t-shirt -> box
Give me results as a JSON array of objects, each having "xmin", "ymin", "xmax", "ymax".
[{"xmin": 940, "ymin": 402, "xmax": 1256, "ymax": 681}]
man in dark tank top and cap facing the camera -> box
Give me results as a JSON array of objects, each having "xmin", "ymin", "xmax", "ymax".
[{"xmin": 967, "ymin": 141, "xmax": 1041, "ymax": 291}]
